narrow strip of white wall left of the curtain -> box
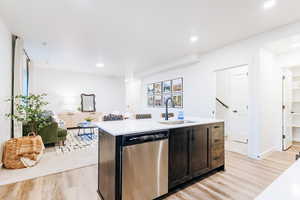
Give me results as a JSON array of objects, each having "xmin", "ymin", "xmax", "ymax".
[{"xmin": 0, "ymin": 18, "xmax": 12, "ymax": 163}]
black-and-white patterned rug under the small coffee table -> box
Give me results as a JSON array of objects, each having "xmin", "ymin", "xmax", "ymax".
[{"xmin": 55, "ymin": 132, "xmax": 98, "ymax": 154}]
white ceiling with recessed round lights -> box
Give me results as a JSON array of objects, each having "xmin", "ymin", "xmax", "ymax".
[{"xmin": 0, "ymin": 0, "xmax": 300, "ymax": 76}]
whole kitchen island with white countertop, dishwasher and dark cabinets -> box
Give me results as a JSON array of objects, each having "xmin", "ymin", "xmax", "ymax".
[{"xmin": 97, "ymin": 118, "xmax": 224, "ymax": 200}]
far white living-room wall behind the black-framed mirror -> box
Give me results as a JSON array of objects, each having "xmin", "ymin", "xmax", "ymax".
[{"xmin": 30, "ymin": 67, "xmax": 125, "ymax": 113}]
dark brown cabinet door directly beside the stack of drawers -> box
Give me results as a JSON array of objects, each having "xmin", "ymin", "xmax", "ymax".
[{"xmin": 190, "ymin": 126, "xmax": 210, "ymax": 177}]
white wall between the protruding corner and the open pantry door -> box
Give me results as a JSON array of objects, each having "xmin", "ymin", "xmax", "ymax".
[{"xmin": 258, "ymin": 49, "xmax": 282, "ymax": 155}]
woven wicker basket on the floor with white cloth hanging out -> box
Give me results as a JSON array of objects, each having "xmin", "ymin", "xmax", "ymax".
[{"xmin": 2, "ymin": 134, "xmax": 45, "ymax": 169}]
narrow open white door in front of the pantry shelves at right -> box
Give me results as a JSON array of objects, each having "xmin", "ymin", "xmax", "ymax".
[{"xmin": 282, "ymin": 69, "xmax": 293, "ymax": 150}]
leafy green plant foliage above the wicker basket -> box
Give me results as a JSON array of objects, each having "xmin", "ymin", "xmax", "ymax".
[{"xmin": 6, "ymin": 94, "xmax": 51, "ymax": 135}]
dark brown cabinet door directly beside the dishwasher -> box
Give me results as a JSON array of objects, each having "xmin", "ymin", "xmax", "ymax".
[{"xmin": 169, "ymin": 128, "xmax": 191, "ymax": 189}]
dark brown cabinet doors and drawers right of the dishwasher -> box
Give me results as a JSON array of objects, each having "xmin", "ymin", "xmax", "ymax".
[{"xmin": 169, "ymin": 123, "xmax": 224, "ymax": 189}]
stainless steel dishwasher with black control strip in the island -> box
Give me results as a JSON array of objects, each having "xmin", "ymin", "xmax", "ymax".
[{"xmin": 122, "ymin": 131, "xmax": 169, "ymax": 200}]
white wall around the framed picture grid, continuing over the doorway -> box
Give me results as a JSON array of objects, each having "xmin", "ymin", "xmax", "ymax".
[{"xmin": 131, "ymin": 23, "xmax": 300, "ymax": 158}]
